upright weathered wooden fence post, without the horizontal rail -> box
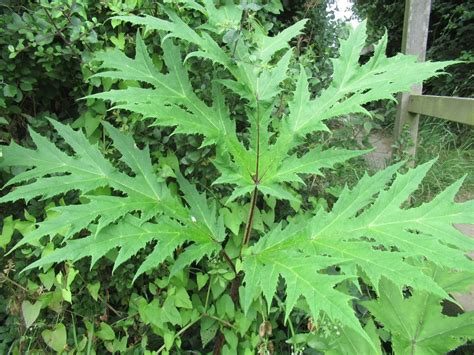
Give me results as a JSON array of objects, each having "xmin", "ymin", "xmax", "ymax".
[{"xmin": 394, "ymin": 0, "xmax": 431, "ymax": 158}]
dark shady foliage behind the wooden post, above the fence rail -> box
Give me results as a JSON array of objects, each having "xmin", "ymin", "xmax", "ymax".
[{"xmin": 354, "ymin": 0, "xmax": 474, "ymax": 97}]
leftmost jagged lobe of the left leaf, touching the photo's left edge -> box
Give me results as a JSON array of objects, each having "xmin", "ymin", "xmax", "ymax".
[{"xmin": 0, "ymin": 121, "xmax": 167, "ymax": 204}]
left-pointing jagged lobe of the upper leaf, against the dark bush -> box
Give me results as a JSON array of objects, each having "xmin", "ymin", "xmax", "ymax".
[{"xmin": 89, "ymin": 33, "xmax": 233, "ymax": 144}]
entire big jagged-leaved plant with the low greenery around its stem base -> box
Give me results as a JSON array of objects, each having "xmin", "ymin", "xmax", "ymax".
[{"xmin": 0, "ymin": 1, "xmax": 474, "ymax": 354}]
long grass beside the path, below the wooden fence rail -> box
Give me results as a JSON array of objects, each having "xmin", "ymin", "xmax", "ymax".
[{"xmin": 301, "ymin": 117, "xmax": 474, "ymax": 209}]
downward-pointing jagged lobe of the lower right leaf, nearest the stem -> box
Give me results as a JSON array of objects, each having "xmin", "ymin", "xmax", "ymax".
[{"xmin": 241, "ymin": 227, "xmax": 371, "ymax": 344}]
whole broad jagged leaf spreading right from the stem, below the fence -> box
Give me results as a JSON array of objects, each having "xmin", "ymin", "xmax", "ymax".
[{"xmin": 242, "ymin": 162, "xmax": 474, "ymax": 344}]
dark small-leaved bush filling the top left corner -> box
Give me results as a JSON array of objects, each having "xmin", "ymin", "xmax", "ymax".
[{"xmin": 0, "ymin": 0, "xmax": 168, "ymax": 145}]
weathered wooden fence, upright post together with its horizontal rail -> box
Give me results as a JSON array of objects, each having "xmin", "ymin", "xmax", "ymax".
[{"xmin": 394, "ymin": 0, "xmax": 474, "ymax": 156}]
